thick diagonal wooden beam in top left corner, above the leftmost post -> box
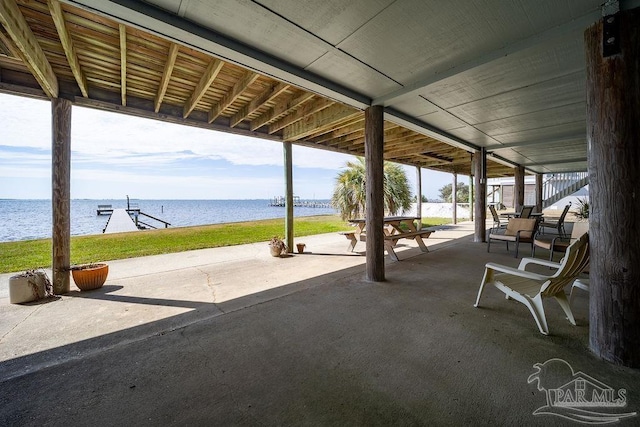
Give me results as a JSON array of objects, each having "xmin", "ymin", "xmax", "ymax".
[{"xmin": 0, "ymin": 0, "xmax": 59, "ymax": 98}]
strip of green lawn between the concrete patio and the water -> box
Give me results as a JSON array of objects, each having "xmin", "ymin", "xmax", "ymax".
[{"xmin": 0, "ymin": 215, "xmax": 458, "ymax": 273}]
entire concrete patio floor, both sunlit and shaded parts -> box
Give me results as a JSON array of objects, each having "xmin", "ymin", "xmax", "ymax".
[{"xmin": 0, "ymin": 223, "xmax": 640, "ymax": 426}]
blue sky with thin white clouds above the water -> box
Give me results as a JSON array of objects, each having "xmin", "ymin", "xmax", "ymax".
[{"xmin": 0, "ymin": 94, "xmax": 468, "ymax": 199}]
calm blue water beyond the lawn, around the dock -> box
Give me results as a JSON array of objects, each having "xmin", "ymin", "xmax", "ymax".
[{"xmin": 0, "ymin": 199, "xmax": 336, "ymax": 242}]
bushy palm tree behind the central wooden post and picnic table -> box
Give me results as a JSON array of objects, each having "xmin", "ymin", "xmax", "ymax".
[{"xmin": 331, "ymin": 157, "xmax": 411, "ymax": 220}]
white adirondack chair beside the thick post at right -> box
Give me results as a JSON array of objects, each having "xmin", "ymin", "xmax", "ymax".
[{"xmin": 474, "ymin": 233, "xmax": 589, "ymax": 335}]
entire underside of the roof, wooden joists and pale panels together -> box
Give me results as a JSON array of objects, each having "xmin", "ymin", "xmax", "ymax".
[{"xmin": 0, "ymin": 0, "xmax": 640, "ymax": 176}]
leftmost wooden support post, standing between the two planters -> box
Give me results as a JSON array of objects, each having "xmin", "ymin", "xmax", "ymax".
[{"xmin": 51, "ymin": 98, "xmax": 71, "ymax": 295}]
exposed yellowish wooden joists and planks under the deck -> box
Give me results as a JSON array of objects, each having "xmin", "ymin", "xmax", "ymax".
[{"xmin": 0, "ymin": 0, "xmax": 513, "ymax": 176}]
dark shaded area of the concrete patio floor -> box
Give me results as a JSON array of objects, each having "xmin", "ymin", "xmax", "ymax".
[{"xmin": 0, "ymin": 231, "xmax": 640, "ymax": 426}]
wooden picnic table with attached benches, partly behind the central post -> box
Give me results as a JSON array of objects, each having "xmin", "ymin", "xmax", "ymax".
[{"xmin": 340, "ymin": 216, "xmax": 435, "ymax": 261}]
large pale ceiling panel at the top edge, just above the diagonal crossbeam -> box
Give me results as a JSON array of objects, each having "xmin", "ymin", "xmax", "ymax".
[{"xmin": 338, "ymin": 0, "xmax": 599, "ymax": 83}]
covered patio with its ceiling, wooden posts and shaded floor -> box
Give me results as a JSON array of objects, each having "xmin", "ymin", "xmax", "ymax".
[{"xmin": 0, "ymin": 0, "xmax": 640, "ymax": 414}]
